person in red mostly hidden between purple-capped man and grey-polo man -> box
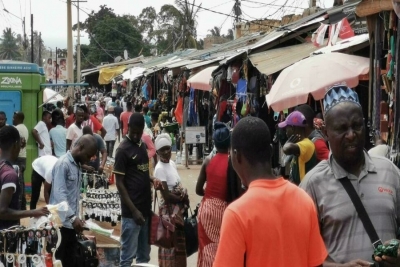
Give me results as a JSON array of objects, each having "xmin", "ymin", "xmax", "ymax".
[{"xmin": 294, "ymin": 104, "xmax": 329, "ymax": 162}]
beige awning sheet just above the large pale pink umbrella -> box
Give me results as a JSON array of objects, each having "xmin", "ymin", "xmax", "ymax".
[{"xmin": 249, "ymin": 43, "xmax": 318, "ymax": 75}]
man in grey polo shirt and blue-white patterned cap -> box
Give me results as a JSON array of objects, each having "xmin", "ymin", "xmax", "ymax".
[{"xmin": 300, "ymin": 86, "xmax": 400, "ymax": 267}]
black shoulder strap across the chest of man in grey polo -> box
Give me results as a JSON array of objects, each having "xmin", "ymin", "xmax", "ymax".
[{"xmin": 339, "ymin": 177, "xmax": 383, "ymax": 266}]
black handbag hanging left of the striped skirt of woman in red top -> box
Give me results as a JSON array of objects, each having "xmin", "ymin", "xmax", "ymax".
[{"xmin": 184, "ymin": 204, "xmax": 200, "ymax": 257}]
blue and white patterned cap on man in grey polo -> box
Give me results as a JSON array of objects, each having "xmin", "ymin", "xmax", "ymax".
[{"xmin": 324, "ymin": 85, "xmax": 361, "ymax": 114}]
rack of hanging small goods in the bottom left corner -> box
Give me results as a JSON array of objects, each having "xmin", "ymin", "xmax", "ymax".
[{"xmin": 0, "ymin": 226, "xmax": 61, "ymax": 267}]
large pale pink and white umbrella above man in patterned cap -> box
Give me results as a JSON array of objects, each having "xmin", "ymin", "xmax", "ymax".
[{"xmin": 266, "ymin": 53, "xmax": 369, "ymax": 111}]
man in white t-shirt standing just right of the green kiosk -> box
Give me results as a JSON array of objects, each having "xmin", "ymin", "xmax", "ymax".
[{"xmin": 32, "ymin": 110, "xmax": 52, "ymax": 157}]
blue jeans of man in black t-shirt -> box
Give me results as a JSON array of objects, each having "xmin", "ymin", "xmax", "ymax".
[{"xmin": 119, "ymin": 217, "xmax": 150, "ymax": 267}]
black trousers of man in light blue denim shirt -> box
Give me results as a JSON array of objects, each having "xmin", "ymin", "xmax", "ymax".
[{"xmin": 56, "ymin": 227, "xmax": 78, "ymax": 267}]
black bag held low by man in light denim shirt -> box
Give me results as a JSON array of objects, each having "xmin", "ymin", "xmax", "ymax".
[{"xmin": 75, "ymin": 234, "xmax": 99, "ymax": 267}]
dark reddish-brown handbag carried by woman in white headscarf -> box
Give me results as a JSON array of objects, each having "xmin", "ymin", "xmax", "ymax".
[{"xmin": 149, "ymin": 195, "xmax": 176, "ymax": 249}]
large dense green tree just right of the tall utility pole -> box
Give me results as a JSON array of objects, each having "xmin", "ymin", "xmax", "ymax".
[{"xmin": 73, "ymin": 5, "xmax": 145, "ymax": 69}]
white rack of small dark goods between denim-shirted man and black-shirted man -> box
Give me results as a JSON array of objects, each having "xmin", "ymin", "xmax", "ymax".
[{"xmin": 82, "ymin": 188, "xmax": 121, "ymax": 226}]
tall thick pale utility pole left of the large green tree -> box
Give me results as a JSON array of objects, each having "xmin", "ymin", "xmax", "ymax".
[{"xmin": 67, "ymin": 0, "xmax": 74, "ymax": 101}]
